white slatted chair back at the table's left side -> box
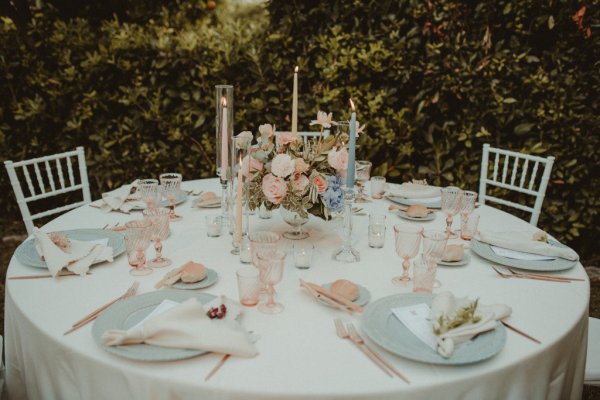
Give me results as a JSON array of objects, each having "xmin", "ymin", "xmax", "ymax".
[{"xmin": 4, "ymin": 147, "xmax": 91, "ymax": 235}]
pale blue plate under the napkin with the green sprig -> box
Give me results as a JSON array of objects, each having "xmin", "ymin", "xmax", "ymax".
[{"xmin": 361, "ymin": 293, "xmax": 506, "ymax": 365}]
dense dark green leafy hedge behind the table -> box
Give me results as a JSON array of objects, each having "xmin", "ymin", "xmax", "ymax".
[{"xmin": 0, "ymin": 0, "xmax": 600, "ymax": 260}]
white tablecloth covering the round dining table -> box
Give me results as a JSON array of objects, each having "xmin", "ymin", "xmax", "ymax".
[{"xmin": 4, "ymin": 179, "xmax": 590, "ymax": 400}]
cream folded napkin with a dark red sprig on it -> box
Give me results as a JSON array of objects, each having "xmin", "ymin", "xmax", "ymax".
[{"xmin": 102, "ymin": 296, "xmax": 258, "ymax": 357}]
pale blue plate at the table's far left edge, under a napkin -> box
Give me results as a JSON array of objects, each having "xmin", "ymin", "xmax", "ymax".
[{"xmin": 15, "ymin": 229, "xmax": 125, "ymax": 268}]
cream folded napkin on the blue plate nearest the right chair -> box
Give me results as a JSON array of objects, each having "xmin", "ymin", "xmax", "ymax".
[{"xmin": 477, "ymin": 230, "xmax": 579, "ymax": 261}]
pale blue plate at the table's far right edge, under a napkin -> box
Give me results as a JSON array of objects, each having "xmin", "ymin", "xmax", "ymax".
[{"xmin": 471, "ymin": 238, "xmax": 577, "ymax": 272}]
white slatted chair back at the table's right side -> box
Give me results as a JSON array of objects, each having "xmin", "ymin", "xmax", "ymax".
[{"xmin": 479, "ymin": 143, "xmax": 554, "ymax": 226}]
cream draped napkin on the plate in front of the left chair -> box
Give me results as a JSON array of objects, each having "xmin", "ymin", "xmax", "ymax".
[{"xmin": 33, "ymin": 228, "xmax": 113, "ymax": 277}]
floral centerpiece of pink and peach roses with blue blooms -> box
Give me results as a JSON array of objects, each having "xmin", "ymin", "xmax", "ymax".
[{"xmin": 237, "ymin": 111, "xmax": 348, "ymax": 219}]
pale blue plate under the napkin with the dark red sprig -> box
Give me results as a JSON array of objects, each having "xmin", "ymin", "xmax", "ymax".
[{"xmin": 92, "ymin": 290, "xmax": 216, "ymax": 361}]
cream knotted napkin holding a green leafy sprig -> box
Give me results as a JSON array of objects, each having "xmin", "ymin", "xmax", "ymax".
[{"xmin": 431, "ymin": 292, "xmax": 512, "ymax": 358}]
